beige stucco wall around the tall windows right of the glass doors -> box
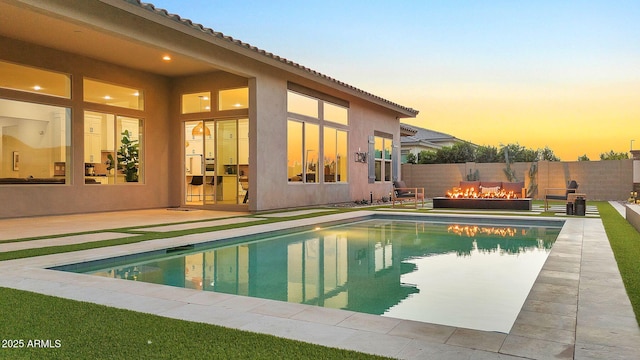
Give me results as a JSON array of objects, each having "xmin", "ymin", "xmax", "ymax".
[{"xmin": 249, "ymin": 69, "xmax": 400, "ymax": 211}]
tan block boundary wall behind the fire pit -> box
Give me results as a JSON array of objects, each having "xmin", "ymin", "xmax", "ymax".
[{"xmin": 402, "ymin": 160, "xmax": 633, "ymax": 200}]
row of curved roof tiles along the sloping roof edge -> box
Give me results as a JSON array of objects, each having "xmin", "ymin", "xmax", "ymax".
[{"xmin": 136, "ymin": 0, "xmax": 419, "ymax": 117}]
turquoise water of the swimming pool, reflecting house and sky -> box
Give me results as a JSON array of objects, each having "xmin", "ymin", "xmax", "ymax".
[{"xmin": 66, "ymin": 219, "xmax": 561, "ymax": 332}]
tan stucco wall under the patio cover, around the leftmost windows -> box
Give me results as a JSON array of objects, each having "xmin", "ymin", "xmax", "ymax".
[{"xmin": 0, "ymin": 37, "xmax": 178, "ymax": 218}]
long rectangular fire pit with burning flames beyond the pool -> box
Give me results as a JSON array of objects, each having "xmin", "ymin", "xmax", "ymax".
[{"xmin": 433, "ymin": 187, "xmax": 531, "ymax": 210}]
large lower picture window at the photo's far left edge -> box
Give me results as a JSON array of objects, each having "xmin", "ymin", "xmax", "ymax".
[{"xmin": 0, "ymin": 99, "xmax": 71, "ymax": 184}]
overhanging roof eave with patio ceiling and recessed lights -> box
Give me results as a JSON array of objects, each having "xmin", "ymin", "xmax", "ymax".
[{"xmin": 0, "ymin": 0, "xmax": 418, "ymax": 118}]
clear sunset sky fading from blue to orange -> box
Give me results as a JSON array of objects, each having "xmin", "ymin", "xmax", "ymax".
[{"xmin": 151, "ymin": 0, "xmax": 640, "ymax": 161}]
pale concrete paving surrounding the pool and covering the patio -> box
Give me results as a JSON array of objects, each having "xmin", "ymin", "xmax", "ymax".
[{"xmin": 0, "ymin": 204, "xmax": 640, "ymax": 359}]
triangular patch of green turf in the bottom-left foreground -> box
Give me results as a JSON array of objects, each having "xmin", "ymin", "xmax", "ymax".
[{"xmin": 0, "ymin": 288, "xmax": 390, "ymax": 359}]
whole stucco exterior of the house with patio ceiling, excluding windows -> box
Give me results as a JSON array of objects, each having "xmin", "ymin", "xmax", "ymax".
[{"xmin": 0, "ymin": 0, "xmax": 417, "ymax": 218}]
